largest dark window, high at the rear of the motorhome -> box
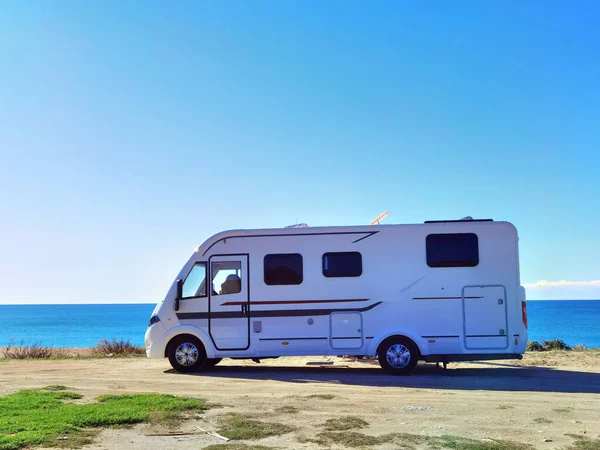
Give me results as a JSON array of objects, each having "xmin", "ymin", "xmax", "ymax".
[{"xmin": 426, "ymin": 233, "xmax": 479, "ymax": 267}]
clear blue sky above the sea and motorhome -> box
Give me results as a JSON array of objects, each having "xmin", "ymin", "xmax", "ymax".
[{"xmin": 0, "ymin": 1, "xmax": 600, "ymax": 303}]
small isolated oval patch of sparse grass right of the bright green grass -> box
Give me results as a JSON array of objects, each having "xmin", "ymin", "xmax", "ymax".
[{"xmin": 217, "ymin": 413, "xmax": 295, "ymax": 440}]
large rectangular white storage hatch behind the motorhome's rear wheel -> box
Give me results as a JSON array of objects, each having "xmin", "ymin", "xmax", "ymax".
[{"xmin": 462, "ymin": 286, "xmax": 508, "ymax": 350}]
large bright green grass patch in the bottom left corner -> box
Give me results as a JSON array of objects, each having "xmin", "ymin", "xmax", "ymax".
[{"xmin": 0, "ymin": 387, "xmax": 207, "ymax": 450}]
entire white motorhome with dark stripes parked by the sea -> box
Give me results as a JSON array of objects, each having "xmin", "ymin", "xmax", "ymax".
[{"xmin": 145, "ymin": 218, "xmax": 527, "ymax": 375}]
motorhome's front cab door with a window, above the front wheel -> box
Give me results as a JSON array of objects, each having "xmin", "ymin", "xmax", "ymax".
[{"xmin": 208, "ymin": 254, "xmax": 250, "ymax": 350}]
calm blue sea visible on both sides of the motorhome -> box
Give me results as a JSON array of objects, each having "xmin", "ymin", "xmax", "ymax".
[{"xmin": 0, "ymin": 300, "xmax": 600, "ymax": 348}]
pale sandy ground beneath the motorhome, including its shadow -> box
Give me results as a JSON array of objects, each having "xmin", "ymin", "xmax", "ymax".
[{"xmin": 0, "ymin": 351, "xmax": 600, "ymax": 450}]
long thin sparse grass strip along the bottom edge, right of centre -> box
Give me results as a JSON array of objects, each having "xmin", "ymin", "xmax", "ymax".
[{"xmin": 298, "ymin": 431, "xmax": 528, "ymax": 450}]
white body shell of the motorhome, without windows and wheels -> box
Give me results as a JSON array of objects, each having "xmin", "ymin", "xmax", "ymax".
[{"xmin": 146, "ymin": 221, "xmax": 527, "ymax": 360}]
